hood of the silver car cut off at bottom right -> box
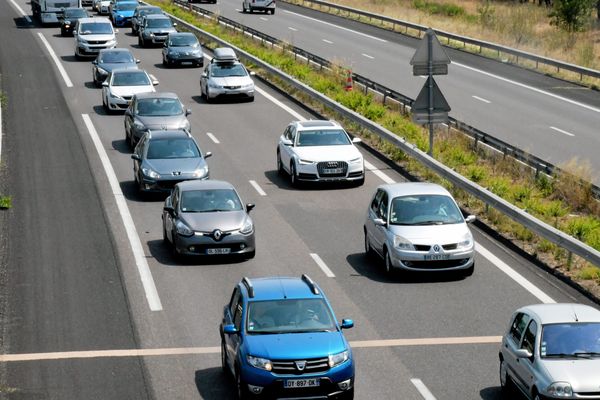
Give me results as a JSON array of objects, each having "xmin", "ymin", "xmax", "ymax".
[{"xmin": 542, "ymin": 358, "xmax": 600, "ymax": 393}]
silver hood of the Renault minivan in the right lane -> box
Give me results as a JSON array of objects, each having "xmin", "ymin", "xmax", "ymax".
[{"xmin": 390, "ymin": 222, "xmax": 469, "ymax": 245}]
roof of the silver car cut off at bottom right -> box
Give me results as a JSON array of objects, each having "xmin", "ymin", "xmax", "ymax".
[{"xmin": 517, "ymin": 303, "xmax": 600, "ymax": 325}]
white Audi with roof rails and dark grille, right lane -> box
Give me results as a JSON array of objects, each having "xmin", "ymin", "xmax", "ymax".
[{"xmin": 277, "ymin": 120, "xmax": 365, "ymax": 186}]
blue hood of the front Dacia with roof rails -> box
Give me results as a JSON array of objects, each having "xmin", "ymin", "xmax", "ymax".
[{"xmin": 245, "ymin": 332, "xmax": 348, "ymax": 360}]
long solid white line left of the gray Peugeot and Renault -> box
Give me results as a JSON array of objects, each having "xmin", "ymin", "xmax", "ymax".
[{"xmin": 81, "ymin": 114, "xmax": 162, "ymax": 311}]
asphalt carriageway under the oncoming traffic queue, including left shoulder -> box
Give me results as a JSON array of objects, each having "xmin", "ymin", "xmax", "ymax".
[{"xmin": 0, "ymin": 0, "xmax": 590, "ymax": 400}]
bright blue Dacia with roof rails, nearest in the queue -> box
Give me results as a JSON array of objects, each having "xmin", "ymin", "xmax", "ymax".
[{"xmin": 219, "ymin": 275, "xmax": 354, "ymax": 399}]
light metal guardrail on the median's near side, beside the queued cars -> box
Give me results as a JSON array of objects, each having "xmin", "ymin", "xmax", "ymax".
[{"xmin": 163, "ymin": 0, "xmax": 600, "ymax": 266}]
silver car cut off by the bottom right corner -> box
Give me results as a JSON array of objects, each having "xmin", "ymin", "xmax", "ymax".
[{"xmin": 499, "ymin": 303, "xmax": 600, "ymax": 400}]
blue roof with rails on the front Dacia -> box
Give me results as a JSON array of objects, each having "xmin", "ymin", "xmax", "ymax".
[{"xmin": 242, "ymin": 275, "xmax": 323, "ymax": 301}]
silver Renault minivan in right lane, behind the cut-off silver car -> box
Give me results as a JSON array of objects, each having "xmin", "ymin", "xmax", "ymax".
[{"xmin": 364, "ymin": 183, "xmax": 475, "ymax": 276}]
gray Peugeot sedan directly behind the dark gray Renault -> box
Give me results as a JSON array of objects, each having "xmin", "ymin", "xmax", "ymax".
[{"xmin": 131, "ymin": 131, "xmax": 212, "ymax": 192}]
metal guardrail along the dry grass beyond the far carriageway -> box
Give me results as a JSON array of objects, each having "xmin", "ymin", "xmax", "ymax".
[{"xmin": 279, "ymin": 0, "xmax": 600, "ymax": 80}]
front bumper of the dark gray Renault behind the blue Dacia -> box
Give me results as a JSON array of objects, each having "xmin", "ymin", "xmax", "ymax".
[{"xmin": 175, "ymin": 228, "xmax": 255, "ymax": 256}]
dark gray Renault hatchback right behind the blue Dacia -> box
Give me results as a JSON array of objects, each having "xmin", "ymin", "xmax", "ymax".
[{"xmin": 162, "ymin": 180, "xmax": 255, "ymax": 258}]
